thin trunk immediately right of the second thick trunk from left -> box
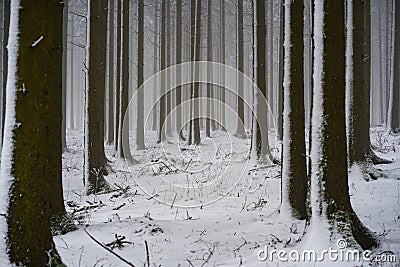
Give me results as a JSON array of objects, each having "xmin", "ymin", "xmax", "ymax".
[{"xmin": 107, "ymin": 0, "xmax": 115, "ymax": 145}]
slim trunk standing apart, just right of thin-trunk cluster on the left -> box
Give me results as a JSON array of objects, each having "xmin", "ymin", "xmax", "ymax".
[{"xmin": 136, "ymin": 0, "xmax": 145, "ymax": 150}]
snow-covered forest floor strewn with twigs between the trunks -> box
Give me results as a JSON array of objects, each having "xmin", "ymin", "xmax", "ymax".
[{"xmin": 54, "ymin": 127, "xmax": 400, "ymax": 266}]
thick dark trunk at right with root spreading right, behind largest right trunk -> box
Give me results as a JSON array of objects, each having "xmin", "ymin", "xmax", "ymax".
[{"xmin": 348, "ymin": 0, "xmax": 390, "ymax": 164}]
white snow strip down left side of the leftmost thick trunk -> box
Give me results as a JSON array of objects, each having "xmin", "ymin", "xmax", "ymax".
[{"xmin": 0, "ymin": 0, "xmax": 20, "ymax": 266}]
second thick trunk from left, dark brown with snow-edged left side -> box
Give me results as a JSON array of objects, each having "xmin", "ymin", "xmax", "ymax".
[{"xmin": 85, "ymin": 0, "xmax": 108, "ymax": 195}]
